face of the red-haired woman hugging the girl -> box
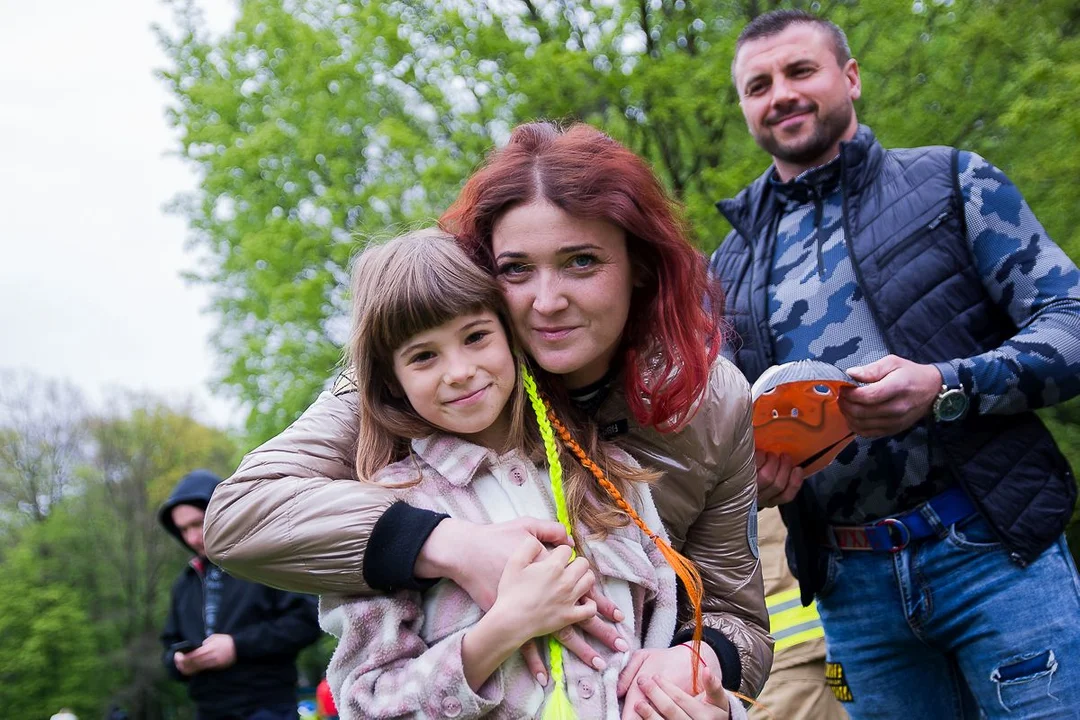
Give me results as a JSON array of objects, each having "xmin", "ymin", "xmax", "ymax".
[{"xmin": 491, "ymin": 201, "xmax": 634, "ymax": 390}]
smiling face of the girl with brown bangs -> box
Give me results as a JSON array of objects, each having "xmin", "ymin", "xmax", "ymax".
[{"xmin": 393, "ymin": 310, "xmax": 517, "ymax": 449}]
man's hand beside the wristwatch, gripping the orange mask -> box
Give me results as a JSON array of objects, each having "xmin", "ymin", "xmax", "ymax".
[{"xmin": 839, "ymin": 355, "xmax": 943, "ymax": 437}]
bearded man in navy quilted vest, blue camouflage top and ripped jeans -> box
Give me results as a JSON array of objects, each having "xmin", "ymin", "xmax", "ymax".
[{"xmin": 712, "ymin": 11, "xmax": 1080, "ymax": 719}]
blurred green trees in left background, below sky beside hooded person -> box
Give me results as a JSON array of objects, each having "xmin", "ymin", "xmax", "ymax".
[{"xmin": 0, "ymin": 386, "xmax": 239, "ymax": 720}]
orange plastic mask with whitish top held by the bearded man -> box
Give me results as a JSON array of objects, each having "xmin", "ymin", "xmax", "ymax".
[{"xmin": 751, "ymin": 361, "xmax": 858, "ymax": 475}]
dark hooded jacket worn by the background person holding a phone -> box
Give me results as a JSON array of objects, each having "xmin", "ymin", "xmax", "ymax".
[{"xmin": 158, "ymin": 470, "xmax": 320, "ymax": 720}]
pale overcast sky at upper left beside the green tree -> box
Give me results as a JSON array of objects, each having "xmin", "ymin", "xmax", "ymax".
[{"xmin": 0, "ymin": 0, "xmax": 238, "ymax": 425}]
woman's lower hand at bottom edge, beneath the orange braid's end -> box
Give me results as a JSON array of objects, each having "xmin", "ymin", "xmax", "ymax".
[{"xmin": 616, "ymin": 642, "xmax": 728, "ymax": 720}]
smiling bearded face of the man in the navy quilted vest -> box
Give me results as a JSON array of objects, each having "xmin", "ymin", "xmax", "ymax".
[{"xmin": 734, "ymin": 24, "xmax": 862, "ymax": 180}]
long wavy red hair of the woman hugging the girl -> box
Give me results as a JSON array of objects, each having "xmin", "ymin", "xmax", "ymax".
[{"xmin": 440, "ymin": 122, "xmax": 723, "ymax": 431}]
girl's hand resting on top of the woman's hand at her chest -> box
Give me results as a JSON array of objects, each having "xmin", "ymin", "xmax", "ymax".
[{"xmin": 489, "ymin": 539, "xmax": 596, "ymax": 642}]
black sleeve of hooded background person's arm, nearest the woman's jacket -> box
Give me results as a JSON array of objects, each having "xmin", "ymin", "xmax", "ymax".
[{"xmin": 232, "ymin": 587, "xmax": 322, "ymax": 661}]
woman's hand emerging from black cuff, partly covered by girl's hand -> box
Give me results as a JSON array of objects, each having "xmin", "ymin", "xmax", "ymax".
[{"xmin": 414, "ymin": 517, "xmax": 629, "ymax": 678}]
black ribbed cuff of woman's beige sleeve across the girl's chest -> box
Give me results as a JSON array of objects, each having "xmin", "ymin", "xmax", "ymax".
[{"xmin": 364, "ymin": 502, "xmax": 449, "ymax": 593}]
